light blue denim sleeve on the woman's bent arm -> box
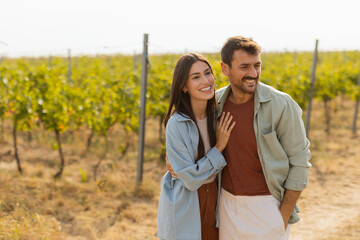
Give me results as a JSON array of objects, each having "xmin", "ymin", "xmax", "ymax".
[{"xmin": 165, "ymin": 116, "xmax": 226, "ymax": 191}]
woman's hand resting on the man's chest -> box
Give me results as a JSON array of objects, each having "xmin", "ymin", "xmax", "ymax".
[{"xmin": 215, "ymin": 112, "xmax": 235, "ymax": 152}]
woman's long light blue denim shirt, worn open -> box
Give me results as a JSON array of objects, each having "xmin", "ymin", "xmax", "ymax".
[{"xmin": 157, "ymin": 112, "xmax": 226, "ymax": 240}]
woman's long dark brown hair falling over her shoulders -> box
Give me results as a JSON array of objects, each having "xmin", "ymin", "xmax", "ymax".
[{"xmin": 164, "ymin": 53, "xmax": 216, "ymax": 160}]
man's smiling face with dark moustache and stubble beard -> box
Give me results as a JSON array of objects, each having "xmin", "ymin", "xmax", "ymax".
[{"xmin": 221, "ymin": 50, "xmax": 261, "ymax": 95}]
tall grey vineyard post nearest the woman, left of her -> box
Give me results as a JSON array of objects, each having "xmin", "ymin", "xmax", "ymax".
[{"xmin": 136, "ymin": 34, "xmax": 148, "ymax": 185}]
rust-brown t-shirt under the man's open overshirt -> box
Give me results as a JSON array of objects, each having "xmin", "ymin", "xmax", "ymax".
[{"xmin": 222, "ymin": 94, "xmax": 270, "ymax": 196}]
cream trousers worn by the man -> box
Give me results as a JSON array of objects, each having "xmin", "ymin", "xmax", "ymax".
[{"xmin": 219, "ymin": 188, "xmax": 290, "ymax": 240}]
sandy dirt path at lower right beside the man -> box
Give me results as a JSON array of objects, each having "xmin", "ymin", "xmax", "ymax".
[{"xmin": 290, "ymin": 139, "xmax": 360, "ymax": 240}]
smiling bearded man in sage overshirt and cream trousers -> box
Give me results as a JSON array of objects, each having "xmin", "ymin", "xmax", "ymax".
[{"xmin": 216, "ymin": 36, "xmax": 311, "ymax": 240}]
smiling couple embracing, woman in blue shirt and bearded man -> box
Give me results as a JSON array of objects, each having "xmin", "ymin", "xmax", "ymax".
[{"xmin": 157, "ymin": 36, "xmax": 311, "ymax": 240}]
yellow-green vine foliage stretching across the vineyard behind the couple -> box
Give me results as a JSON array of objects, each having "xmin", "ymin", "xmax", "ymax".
[{"xmin": 0, "ymin": 51, "xmax": 360, "ymax": 154}]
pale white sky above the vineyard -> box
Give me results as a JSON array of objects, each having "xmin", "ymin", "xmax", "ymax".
[{"xmin": 0, "ymin": 0, "xmax": 360, "ymax": 57}]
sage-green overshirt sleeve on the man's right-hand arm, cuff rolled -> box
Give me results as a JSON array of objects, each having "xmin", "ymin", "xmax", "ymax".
[{"xmin": 276, "ymin": 97, "xmax": 311, "ymax": 191}]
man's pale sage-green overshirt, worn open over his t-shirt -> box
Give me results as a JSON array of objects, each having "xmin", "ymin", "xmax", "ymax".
[{"xmin": 216, "ymin": 82, "xmax": 311, "ymax": 224}]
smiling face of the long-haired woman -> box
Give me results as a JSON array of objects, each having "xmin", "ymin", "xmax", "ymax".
[{"xmin": 183, "ymin": 61, "xmax": 215, "ymax": 104}]
